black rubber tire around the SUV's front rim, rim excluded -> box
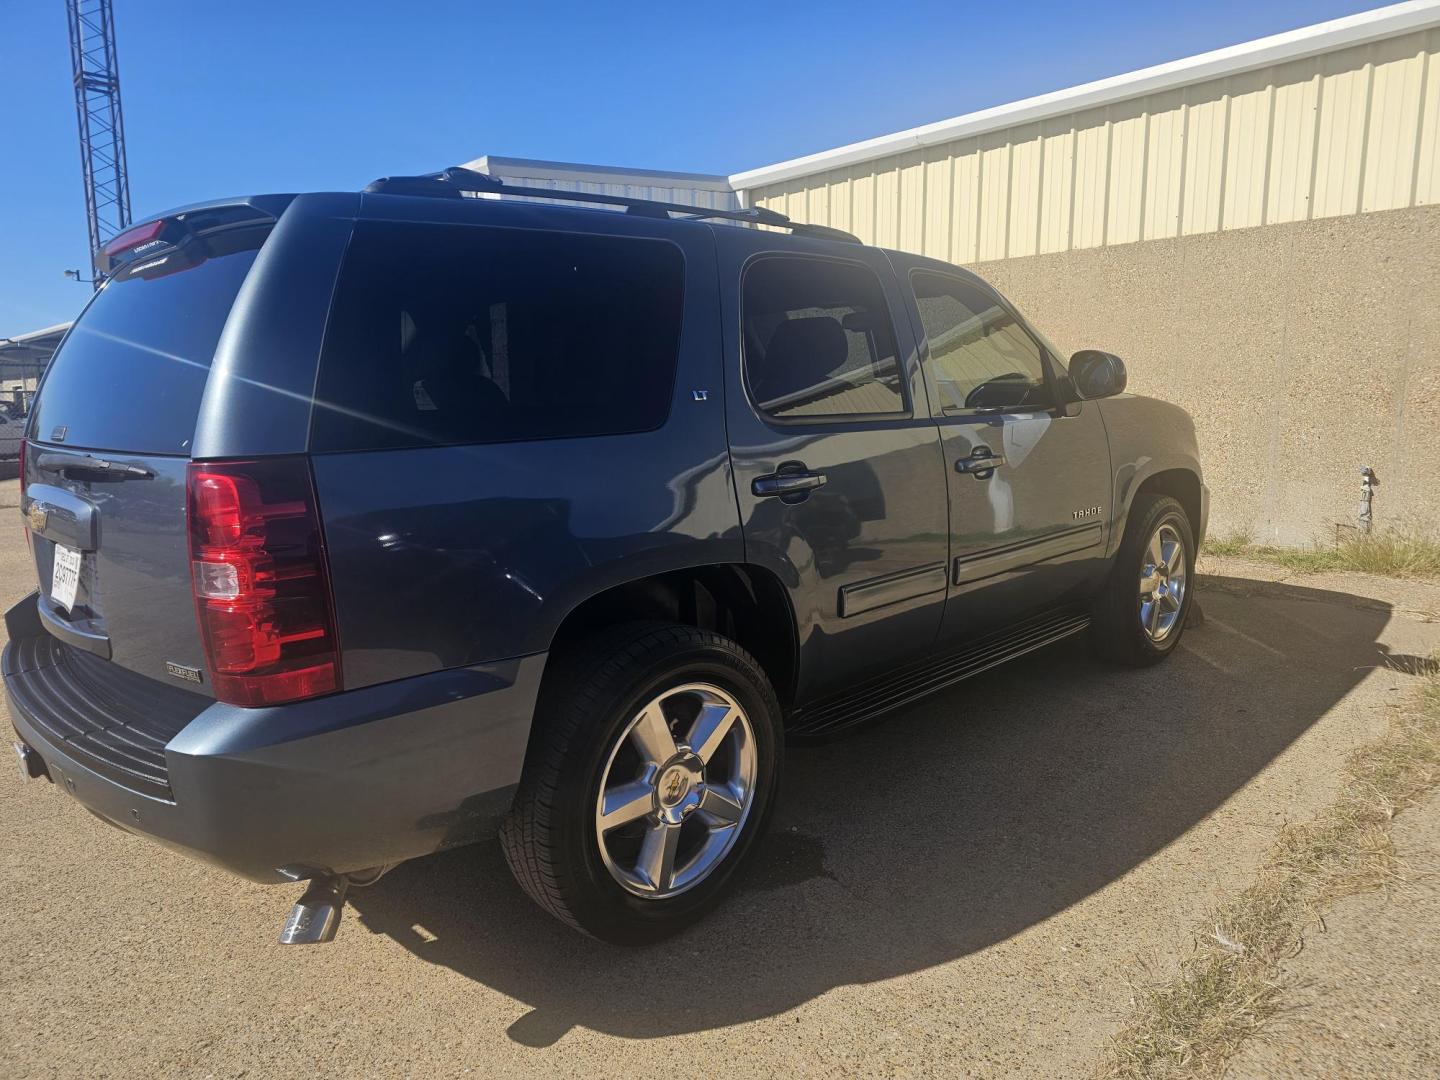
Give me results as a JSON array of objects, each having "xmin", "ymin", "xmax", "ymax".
[{"xmin": 1090, "ymin": 494, "xmax": 1195, "ymax": 667}]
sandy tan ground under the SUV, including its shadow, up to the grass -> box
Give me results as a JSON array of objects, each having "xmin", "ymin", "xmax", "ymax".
[{"xmin": 0, "ymin": 481, "xmax": 1440, "ymax": 1077}]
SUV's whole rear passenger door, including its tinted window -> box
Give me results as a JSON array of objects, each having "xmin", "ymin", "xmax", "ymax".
[{"xmin": 716, "ymin": 228, "xmax": 949, "ymax": 703}]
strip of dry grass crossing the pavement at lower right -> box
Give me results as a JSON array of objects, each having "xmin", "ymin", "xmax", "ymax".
[{"xmin": 1100, "ymin": 659, "xmax": 1440, "ymax": 1080}]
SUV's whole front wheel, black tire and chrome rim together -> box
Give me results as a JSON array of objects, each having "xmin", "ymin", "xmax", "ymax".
[{"xmin": 1092, "ymin": 495, "xmax": 1195, "ymax": 667}]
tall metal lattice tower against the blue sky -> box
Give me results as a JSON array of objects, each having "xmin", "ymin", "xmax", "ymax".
[{"xmin": 65, "ymin": 0, "xmax": 130, "ymax": 285}]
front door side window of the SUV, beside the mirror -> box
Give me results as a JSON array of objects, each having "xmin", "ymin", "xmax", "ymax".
[{"xmin": 910, "ymin": 271, "xmax": 1050, "ymax": 412}]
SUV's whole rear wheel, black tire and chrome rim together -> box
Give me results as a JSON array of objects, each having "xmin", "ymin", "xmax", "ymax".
[{"xmin": 501, "ymin": 624, "xmax": 782, "ymax": 943}]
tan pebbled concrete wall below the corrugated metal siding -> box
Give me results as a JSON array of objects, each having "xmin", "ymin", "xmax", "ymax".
[{"xmin": 975, "ymin": 206, "xmax": 1440, "ymax": 544}]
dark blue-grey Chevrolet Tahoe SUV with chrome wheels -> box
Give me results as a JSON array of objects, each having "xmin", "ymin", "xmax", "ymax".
[{"xmin": 3, "ymin": 168, "xmax": 1207, "ymax": 943}]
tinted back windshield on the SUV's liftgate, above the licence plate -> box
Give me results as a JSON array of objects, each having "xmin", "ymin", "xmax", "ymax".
[{"xmin": 30, "ymin": 229, "xmax": 265, "ymax": 454}]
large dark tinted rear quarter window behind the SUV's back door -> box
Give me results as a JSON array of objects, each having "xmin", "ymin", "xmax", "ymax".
[{"xmin": 312, "ymin": 222, "xmax": 684, "ymax": 451}]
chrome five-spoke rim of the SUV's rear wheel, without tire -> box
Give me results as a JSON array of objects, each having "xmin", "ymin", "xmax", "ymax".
[{"xmin": 595, "ymin": 683, "xmax": 757, "ymax": 900}]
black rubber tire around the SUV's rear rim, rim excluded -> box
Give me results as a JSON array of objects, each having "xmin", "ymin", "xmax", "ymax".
[{"xmin": 500, "ymin": 624, "xmax": 783, "ymax": 945}]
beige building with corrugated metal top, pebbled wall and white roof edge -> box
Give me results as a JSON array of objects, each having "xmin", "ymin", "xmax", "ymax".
[{"xmin": 730, "ymin": 0, "xmax": 1440, "ymax": 544}]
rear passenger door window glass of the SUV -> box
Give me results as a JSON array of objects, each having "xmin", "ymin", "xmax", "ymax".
[{"xmin": 740, "ymin": 255, "xmax": 906, "ymax": 419}]
